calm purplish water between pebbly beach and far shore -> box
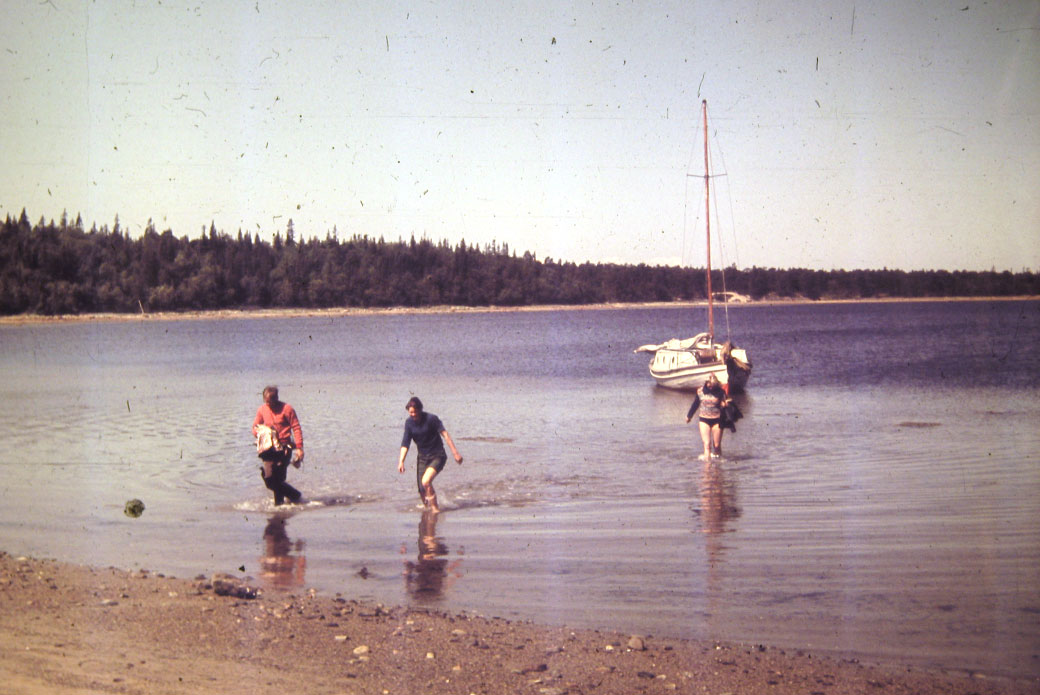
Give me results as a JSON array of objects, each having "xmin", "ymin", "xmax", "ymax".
[{"xmin": 0, "ymin": 302, "xmax": 1040, "ymax": 676}]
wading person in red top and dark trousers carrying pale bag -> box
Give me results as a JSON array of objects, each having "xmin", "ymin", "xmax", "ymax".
[{"xmin": 253, "ymin": 386, "xmax": 304, "ymax": 507}]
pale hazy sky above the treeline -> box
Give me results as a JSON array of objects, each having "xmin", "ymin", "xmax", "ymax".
[{"xmin": 0, "ymin": 0, "xmax": 1040, "ymax": 272}]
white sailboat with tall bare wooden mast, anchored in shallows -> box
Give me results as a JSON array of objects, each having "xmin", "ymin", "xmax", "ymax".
[{"xmin": 634, "ymin": 100, "xmax": 751, "ymax": 393}]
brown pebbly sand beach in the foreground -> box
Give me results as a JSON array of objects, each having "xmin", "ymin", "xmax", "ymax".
[{"xmin": 0, "ymin": 552, "xmax": 1040, "ymax": 695}]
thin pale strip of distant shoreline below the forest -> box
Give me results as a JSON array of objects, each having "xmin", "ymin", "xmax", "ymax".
[{"xmin": 0, "ymin": 295, "xmax": 1040, "ymax": 326}]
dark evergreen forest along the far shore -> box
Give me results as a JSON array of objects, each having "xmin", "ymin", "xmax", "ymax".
[{"xmin": 0, "ymin": 210, "xmax": 1040, "ymax": 315}]
